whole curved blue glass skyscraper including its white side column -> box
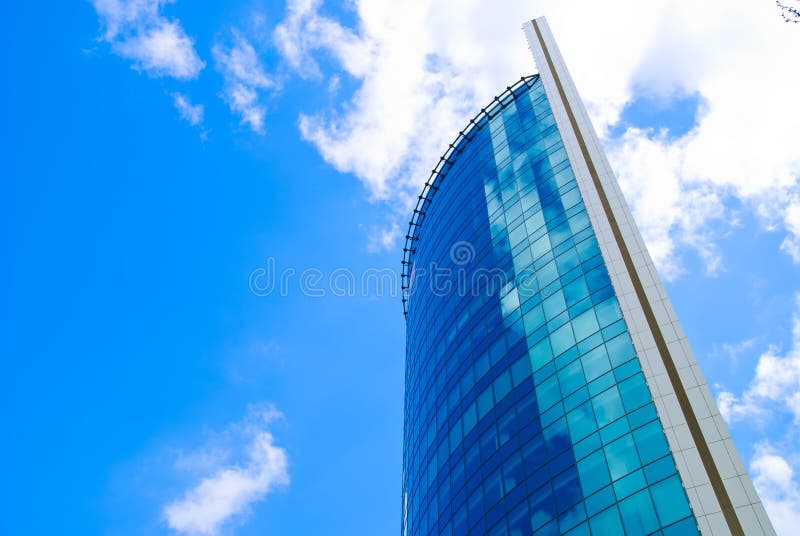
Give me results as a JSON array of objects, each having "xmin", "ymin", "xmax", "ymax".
[{"xmin": 402, "ymin": 19, "xmax": 774, "ymax": 536}]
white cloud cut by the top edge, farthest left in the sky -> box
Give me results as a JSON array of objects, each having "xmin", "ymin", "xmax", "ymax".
[{"xmin": 92, "ymin": 0, "xmax": 205, "ymax": 80}]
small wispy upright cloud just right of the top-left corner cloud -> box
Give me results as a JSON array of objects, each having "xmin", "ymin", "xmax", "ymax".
[{"xmin": 212, "ymin": 30, "xmax": 277, "ymax": 133}]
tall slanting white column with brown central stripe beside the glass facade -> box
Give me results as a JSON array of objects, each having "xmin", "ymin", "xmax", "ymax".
[{"xmin": 523, "ymin": 18, "xmax": 775, "ymax": 536}]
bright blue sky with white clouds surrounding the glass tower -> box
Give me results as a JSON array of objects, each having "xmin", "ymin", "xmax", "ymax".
[{"xmin": 0, "ymin": 0, "xmax": 800, "ymax": 534}]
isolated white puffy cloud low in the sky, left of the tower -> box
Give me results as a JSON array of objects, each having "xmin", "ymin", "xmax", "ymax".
[{"xmin": 163, "ymin": 405, "xmax": 289, "ymax": 534}]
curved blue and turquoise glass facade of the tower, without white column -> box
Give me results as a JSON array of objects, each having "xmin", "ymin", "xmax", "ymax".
[{"xmin": 402, "ymin": 77, "xmax": 697, "ymax": 536}]
